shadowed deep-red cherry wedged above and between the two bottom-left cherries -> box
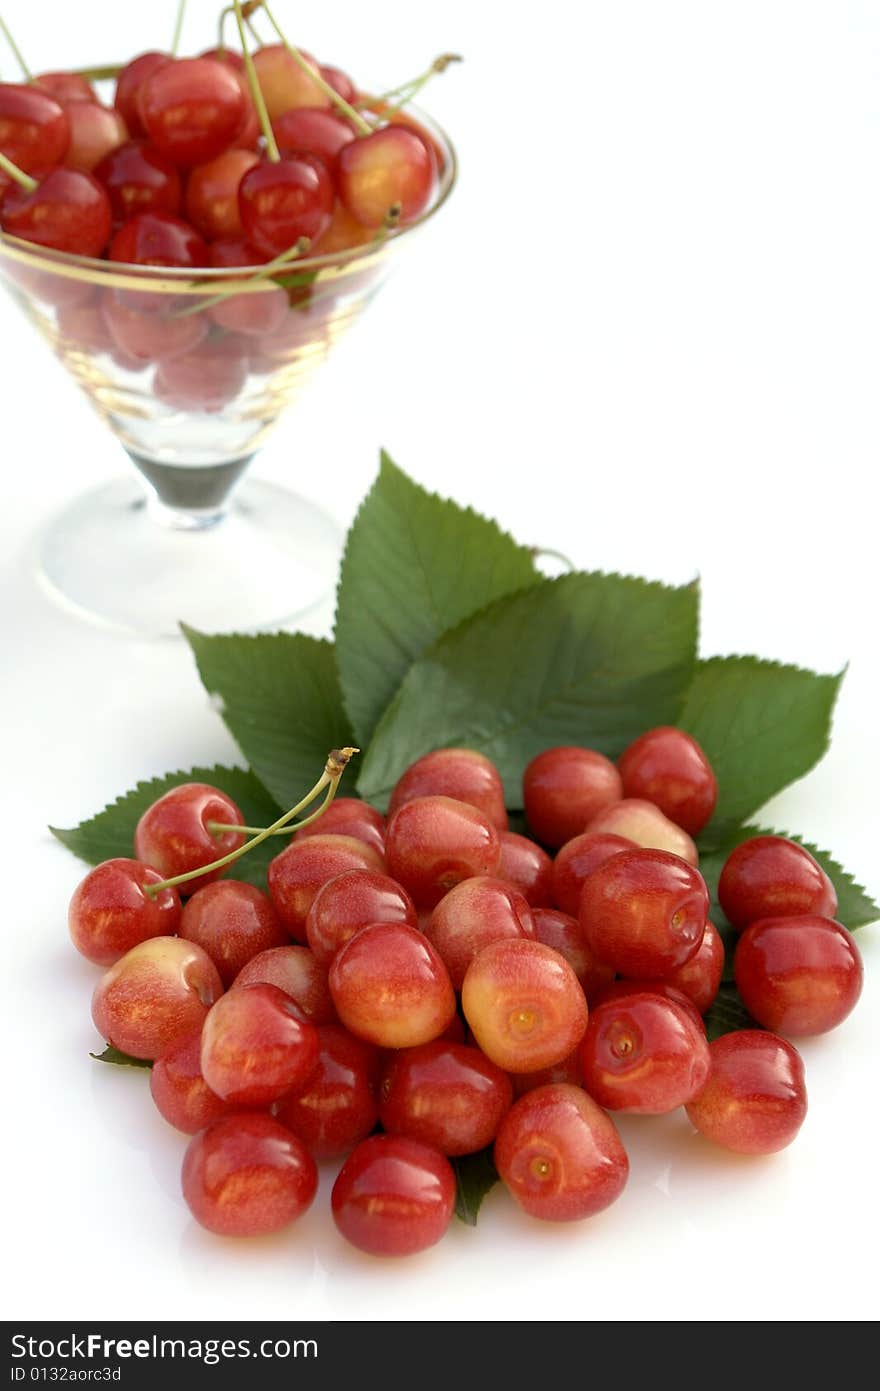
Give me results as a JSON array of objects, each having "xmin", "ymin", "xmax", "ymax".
[{"xmin": 278, "ymin": 1024, "xmax": 380, "ymax": 1159}]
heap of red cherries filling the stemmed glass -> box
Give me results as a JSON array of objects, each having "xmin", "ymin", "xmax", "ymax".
[{"xmin": 0, "ymin": 9, "xmax": 443, "ymax": 410}]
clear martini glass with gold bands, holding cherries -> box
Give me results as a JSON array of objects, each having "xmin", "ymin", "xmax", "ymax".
[{"xmin": 0, "ymin": 111, "xmax": 456, "ymax": 637}]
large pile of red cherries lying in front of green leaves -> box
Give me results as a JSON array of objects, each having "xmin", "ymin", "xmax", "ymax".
[{"xmin": 70, "ymin": 727, "xmax": 862, "ymax": 1255}]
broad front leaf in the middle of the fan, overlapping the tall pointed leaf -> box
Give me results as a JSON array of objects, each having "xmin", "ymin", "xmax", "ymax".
[{"xmin": 359, "ymin": 574, "xmax": 698, "ymax": 808}]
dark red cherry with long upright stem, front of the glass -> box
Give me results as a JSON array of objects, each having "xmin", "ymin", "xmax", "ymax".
[{"xmin": 238, "ymin": 154, "xmax": 334, "ymax": 256}]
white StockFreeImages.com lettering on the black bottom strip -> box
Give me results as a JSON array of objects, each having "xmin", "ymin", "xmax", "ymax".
[{"xmin": 11, "ymin": 1333, "xmax": 318, "ymax": 1381}]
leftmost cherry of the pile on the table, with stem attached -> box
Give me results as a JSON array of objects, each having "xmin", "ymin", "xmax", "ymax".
[{"xmin": 67, "ymin": 860, "xmax": 181, "ymax": 965}]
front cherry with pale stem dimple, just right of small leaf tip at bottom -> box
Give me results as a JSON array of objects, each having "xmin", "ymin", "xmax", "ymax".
[{"xmin": 495, "ymin": 1084, "xmax": 630, "ymax": 1221}]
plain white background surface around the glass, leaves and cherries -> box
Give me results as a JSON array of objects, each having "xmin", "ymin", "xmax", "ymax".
[{"xmin": 0, "ymin": 0, "xmax": 880, "ymax": 1320}]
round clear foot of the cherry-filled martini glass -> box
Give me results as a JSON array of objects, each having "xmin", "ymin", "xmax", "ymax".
[{"xmin": 39, "ymin": 479, "xmax": 342, "ymax": 637}]
